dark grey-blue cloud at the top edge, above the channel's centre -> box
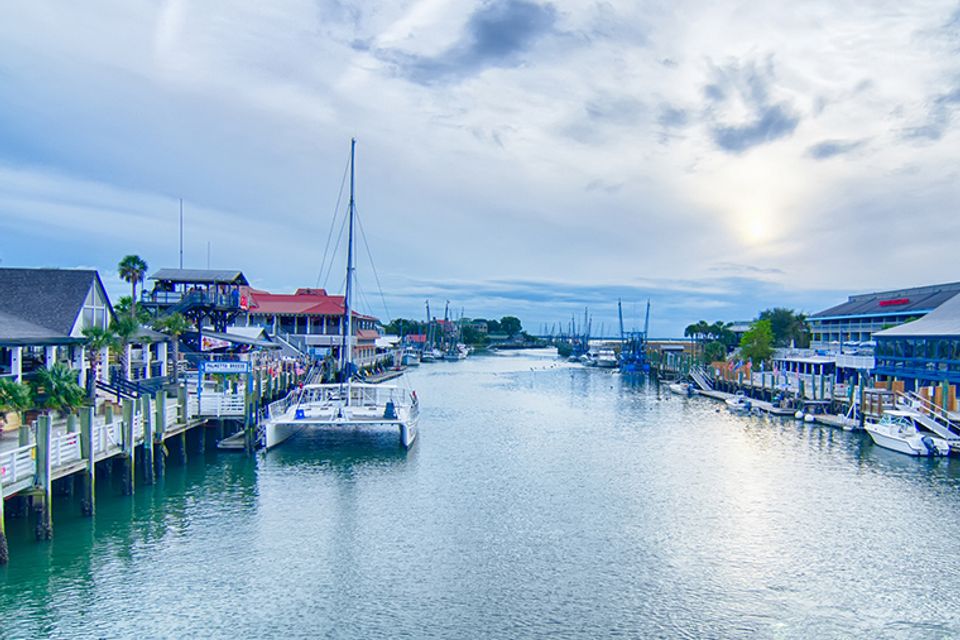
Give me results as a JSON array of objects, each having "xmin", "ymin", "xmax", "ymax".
[{"xmin": 377, "ymin": 0, "xmax": 557, "ymax": 85}]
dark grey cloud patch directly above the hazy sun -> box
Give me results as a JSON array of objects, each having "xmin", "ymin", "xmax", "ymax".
[{"xmin": 703, "ymin": 59, "xmax": 800, "ymax": 154}]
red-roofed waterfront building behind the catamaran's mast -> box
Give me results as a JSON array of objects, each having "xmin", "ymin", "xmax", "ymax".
[{"xmin": 241, "ymin": 287, "xmax": 382, "ymax": 367}]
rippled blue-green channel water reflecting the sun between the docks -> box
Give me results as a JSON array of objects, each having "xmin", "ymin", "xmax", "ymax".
[{"xmin": 0, "ymin": 353, "xmax": 960, "ymax": 638}]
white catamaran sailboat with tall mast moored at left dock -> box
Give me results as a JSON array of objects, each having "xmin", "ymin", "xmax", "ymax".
[{"xmin": 261, "ymin": 139, "xmax": 420, "ymax": 449}]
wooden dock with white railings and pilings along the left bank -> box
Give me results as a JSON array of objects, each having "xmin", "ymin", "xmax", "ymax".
[{"xmin": 0, "ymin": 363, "xmax": 310, "ymax": 564}]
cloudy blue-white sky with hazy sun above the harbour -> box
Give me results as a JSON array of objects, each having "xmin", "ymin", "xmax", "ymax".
[{"xmin": 0, "ymin": 0, "xmax": 960, "ymax": 337}]
